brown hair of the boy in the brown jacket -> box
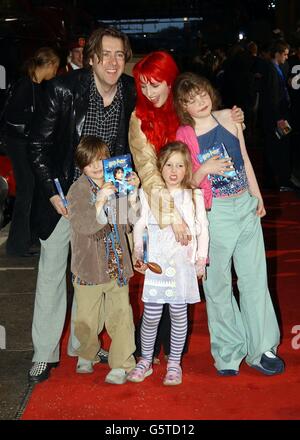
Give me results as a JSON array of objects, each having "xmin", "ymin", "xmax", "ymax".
[{"xmin": 75, "ymin": 136, "xmax": 110, "ymax": 171}]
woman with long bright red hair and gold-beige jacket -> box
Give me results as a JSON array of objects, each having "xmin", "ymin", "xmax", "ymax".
[{"xmin": 129, "ymin": 51, "xmax": 244, "ymax": 374}]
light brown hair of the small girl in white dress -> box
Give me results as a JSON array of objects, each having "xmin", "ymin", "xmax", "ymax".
[{"xmin": 157, "ymin": 141, "xmax": 193, "ymax": 189}]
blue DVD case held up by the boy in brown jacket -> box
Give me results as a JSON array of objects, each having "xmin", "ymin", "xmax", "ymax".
[{"xmin": 103, "ymin": 154, "xmax": 134, "ymax": 197}]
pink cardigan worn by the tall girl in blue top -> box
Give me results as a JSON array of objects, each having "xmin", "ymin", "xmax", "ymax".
[{"xmin": 176, "ymin": 125, "xmax": 212, "ymax": 209}]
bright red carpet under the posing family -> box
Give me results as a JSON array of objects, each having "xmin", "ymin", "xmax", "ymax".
[{"xmin": 22, "ymin": 193, "xmax": 300, "ymax": 420}]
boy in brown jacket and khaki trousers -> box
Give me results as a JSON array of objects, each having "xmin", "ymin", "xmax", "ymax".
[{"xmin": 67, "ymin": 136, "xmax": 139, "ymax": 384}]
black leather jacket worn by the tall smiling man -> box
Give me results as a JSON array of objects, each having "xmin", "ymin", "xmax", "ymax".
[{"xmin": 29, "ymin": 69, "xmax": 136, "ymax": 240}]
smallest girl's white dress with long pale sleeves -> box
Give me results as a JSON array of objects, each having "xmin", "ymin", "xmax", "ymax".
[{"xmin": 134, "ymin": 189, "xmax": 208, "ymax": 304}]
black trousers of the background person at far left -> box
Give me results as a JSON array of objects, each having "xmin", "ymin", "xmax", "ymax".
[{"xmin": 5, "ymin": 137, "xmax": 34, "ymax": 256}]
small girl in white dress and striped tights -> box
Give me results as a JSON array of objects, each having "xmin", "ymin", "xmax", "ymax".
[{"xmin": 127, "ymin": 142, "xmax": 208, "ymax": 385}]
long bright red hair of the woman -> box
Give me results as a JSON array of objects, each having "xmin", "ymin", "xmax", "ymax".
[{"xmin": 133, "ymin": 51, "xmax": 179, "ymax": 152}]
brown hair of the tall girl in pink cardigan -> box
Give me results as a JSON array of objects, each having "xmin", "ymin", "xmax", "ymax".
[{"xmin": 174, "ymin": 72, "xmax": 220, "ymax": 127}]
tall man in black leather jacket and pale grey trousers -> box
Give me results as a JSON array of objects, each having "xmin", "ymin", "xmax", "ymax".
[{"xmin": 29, "ymin": 28, "xmax": 135, "ymax": 383}]
